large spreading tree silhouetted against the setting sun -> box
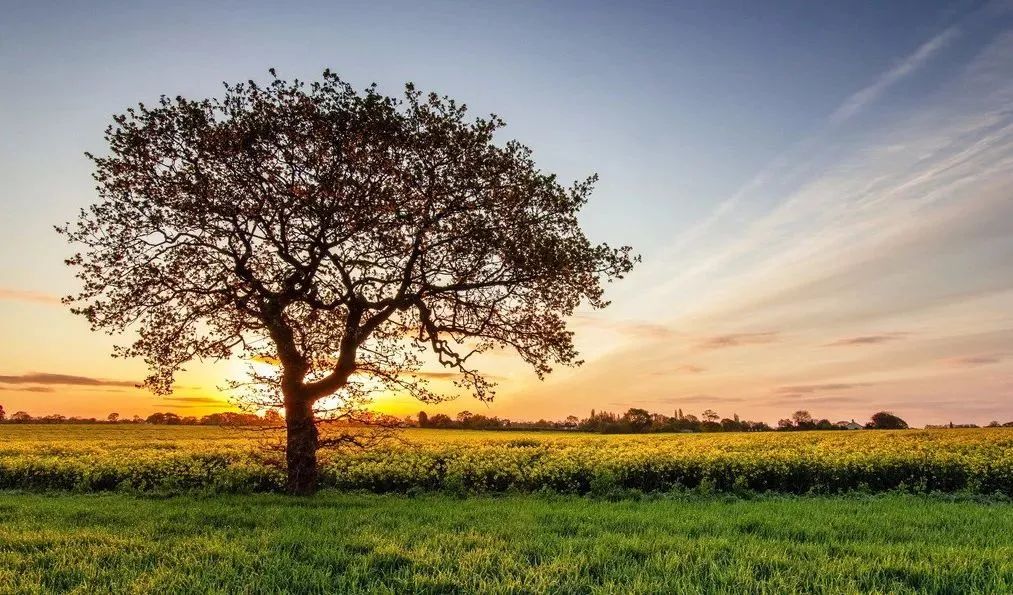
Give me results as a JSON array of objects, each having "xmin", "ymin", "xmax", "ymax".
[{"xmin": 59, "ymin": 70, "xmax": 636, "ymax": 494}]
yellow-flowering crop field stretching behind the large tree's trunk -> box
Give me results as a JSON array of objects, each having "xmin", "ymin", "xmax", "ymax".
[{"xmin": 0, "ymin": 424, "xmax": 1013, "ymax": 496}]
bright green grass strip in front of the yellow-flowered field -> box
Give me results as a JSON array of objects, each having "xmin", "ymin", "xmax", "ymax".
[{"xmin": 0, "ymin": 492, "xmax": 1013, "ymax": 593}]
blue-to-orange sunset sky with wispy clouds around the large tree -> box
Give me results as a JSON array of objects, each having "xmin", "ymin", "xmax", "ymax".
[{"xmin": 0, "ymin": 0, "xmax": 1013, "ymax": 425}]
